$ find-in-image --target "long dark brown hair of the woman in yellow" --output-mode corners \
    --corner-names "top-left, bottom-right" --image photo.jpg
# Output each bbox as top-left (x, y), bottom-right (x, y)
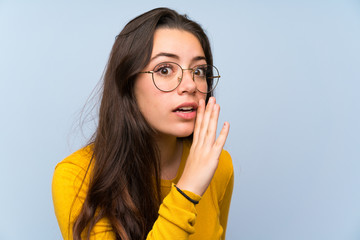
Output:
top-left (73, 8), bottom-right (213, 240)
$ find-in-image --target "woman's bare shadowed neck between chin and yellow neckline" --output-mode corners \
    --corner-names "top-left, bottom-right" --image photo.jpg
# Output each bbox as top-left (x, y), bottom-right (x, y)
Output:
top-left (156, 136), bottom-right (182, 179)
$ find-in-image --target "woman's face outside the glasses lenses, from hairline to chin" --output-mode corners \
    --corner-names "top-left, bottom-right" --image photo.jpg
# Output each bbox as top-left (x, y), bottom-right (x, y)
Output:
top-left (134, 28), bottom-right (206, 137)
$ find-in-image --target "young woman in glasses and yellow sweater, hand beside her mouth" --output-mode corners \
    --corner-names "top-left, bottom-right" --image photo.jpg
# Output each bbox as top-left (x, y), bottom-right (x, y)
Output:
top-left (52, 8), bottom-right (234, 240)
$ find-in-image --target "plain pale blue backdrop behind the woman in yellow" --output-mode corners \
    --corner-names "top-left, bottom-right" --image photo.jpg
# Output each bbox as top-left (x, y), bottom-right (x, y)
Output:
top-left (0, 0), bottom-right (360, 240)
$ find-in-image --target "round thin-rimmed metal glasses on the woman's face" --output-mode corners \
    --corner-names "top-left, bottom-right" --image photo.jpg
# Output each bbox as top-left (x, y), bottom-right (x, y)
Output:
top-left (140, 62), bottom-right (220, 94)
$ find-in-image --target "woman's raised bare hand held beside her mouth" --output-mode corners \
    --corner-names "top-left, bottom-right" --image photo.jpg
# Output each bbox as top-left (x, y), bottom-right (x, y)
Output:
top-left (177, 97), bottom-right (230, 196)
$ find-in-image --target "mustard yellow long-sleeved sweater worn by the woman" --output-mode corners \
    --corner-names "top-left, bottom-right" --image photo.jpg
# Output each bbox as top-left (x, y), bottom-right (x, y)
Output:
top-left (52, 142), bottom-right (234, 240)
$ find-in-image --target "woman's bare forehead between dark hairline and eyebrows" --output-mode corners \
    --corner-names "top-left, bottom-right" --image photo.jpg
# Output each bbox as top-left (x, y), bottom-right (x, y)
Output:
top-left (151, 28), bottom-right (205, 58)
